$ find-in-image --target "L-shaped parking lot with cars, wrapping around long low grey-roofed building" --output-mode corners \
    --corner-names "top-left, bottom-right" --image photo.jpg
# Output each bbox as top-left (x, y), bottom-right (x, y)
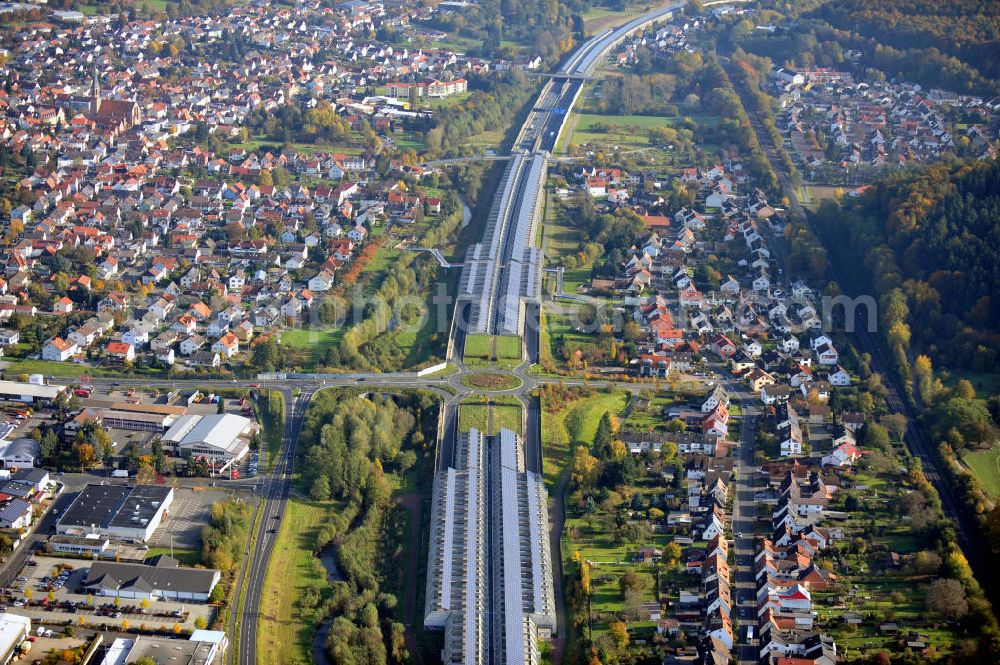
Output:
top-left (6, 556), bottom-right (214, 630)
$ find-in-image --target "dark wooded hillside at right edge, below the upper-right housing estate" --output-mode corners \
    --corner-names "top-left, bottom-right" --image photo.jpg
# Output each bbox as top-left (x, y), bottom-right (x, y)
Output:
top-left (814, 160), bottom-right (1000, 371)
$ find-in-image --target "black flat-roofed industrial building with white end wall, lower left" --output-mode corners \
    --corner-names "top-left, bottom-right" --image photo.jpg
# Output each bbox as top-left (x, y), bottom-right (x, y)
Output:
top-left (56, 485), bottom-right (174, 542)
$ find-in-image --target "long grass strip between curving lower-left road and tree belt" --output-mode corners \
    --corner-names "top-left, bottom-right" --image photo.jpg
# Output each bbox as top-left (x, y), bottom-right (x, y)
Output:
top-left (256, 498), bottom-right (333, 663)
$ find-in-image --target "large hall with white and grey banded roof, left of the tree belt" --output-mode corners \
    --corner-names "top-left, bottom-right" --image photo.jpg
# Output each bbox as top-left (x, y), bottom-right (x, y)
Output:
top-left (162, 413), bottom-right (258, 472)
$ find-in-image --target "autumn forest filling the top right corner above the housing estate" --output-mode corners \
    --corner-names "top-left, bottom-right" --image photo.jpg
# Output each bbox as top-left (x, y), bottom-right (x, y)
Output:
top-left (730, 0), bottom-right (1000, 96)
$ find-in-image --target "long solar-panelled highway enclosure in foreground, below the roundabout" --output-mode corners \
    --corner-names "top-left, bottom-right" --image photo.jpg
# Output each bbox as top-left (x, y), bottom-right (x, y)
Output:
top-left (424, 429), bottom-right (556, 665)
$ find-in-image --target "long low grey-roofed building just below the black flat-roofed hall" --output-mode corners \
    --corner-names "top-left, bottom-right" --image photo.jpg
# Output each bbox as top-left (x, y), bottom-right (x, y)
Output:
top-left (83, 554), bottom-right (222, 602)
